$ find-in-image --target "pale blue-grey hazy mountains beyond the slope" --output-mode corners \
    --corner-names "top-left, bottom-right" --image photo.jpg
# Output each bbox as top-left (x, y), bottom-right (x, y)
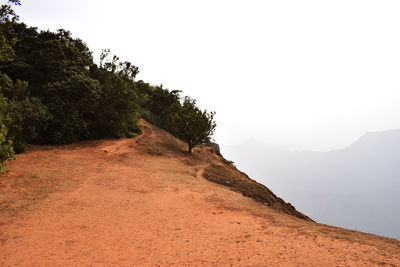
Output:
top-left (222, 130), bottom-right (400, 239)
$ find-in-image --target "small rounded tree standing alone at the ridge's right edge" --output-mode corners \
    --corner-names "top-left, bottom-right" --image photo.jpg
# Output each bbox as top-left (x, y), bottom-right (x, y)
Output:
top-left (175, 97), bottom-right (217, 153)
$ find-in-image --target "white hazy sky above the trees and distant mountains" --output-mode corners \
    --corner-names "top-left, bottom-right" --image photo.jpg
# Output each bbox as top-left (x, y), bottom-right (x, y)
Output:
top-left (12, 0), bottom-right (400, 151)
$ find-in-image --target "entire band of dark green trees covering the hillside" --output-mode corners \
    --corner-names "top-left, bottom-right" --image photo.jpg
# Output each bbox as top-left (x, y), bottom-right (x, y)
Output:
top-left (0, 0), bottom-right (215, 171)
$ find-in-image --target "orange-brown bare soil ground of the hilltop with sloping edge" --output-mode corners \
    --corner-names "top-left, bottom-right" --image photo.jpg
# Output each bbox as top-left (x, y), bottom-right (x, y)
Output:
top-left (0, 122), bottom-right (400, 266)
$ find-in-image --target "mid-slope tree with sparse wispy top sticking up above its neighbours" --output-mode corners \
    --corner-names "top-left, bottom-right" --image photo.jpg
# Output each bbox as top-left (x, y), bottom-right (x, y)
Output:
top-left (91, 50), bottom-right (140, 138)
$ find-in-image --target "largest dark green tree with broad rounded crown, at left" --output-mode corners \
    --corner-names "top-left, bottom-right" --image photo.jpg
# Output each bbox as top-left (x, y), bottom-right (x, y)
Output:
top-left (3, 23), bottom-right (101, 144)
